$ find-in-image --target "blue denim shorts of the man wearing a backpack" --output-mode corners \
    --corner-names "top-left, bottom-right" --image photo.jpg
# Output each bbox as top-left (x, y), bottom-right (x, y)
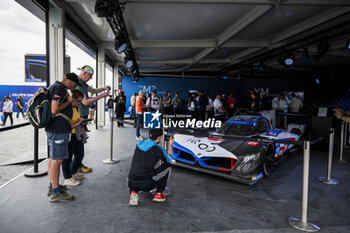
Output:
top-left (46, 132), bottom-right (70, 160)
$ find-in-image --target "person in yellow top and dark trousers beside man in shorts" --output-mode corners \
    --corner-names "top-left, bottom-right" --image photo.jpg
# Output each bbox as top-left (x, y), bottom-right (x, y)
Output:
top-left (62, 90), bottom-right (87, 186)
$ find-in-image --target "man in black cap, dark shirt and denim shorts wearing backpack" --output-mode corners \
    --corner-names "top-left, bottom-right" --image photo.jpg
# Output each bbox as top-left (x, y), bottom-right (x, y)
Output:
top-left (45, 73), bottom-right (80, 202)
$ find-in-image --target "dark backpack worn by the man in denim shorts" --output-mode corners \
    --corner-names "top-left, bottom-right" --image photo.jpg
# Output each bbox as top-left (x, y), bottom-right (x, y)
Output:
top-left (27, 87), bottom-right (70, 128)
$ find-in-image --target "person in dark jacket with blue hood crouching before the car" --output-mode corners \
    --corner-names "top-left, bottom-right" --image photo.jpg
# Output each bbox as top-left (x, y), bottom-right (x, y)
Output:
top-left (128, 129), bottom-right (174, 205)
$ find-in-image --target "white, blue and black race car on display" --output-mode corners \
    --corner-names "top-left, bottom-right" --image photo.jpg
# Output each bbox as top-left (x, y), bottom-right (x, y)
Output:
top-left (173, 115), bottom-right (305, 184)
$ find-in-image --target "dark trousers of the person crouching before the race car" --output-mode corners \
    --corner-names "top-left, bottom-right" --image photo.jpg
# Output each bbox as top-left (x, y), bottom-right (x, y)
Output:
top-left (128, 163), bottom-right (171, 193)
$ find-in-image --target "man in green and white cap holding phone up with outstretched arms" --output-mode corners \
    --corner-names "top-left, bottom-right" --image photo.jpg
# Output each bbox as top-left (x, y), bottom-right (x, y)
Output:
top-left (77, 65), bottom-right (111, 173)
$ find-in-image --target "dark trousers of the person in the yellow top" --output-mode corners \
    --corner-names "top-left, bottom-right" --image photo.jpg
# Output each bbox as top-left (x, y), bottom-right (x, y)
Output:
top-left (62, 134), bottom-right (84, 179)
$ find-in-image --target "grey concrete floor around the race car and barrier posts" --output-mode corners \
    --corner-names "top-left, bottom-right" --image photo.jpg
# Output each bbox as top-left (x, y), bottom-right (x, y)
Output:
top-left (0, 123), bottom-right (350, 233)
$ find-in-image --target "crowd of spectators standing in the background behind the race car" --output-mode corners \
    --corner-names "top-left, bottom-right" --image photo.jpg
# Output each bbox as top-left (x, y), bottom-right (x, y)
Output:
top-left (126, 90), bottom-right (303, 123)
